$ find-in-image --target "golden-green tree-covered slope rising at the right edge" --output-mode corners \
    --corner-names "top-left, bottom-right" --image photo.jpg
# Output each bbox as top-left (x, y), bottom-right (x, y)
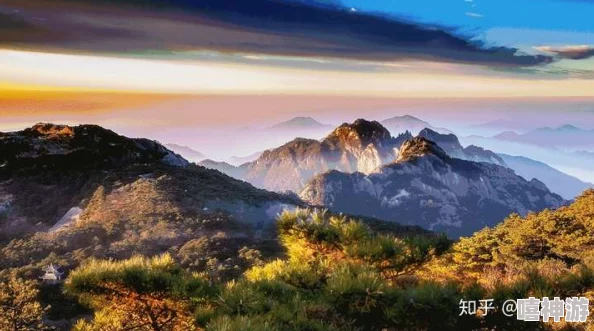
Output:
top-left (434, 189), bottom-right (594, 282)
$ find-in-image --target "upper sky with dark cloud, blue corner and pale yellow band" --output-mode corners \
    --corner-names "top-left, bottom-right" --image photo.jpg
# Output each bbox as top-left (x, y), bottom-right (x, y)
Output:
top-left (0, 0), bottom-right (594, 97)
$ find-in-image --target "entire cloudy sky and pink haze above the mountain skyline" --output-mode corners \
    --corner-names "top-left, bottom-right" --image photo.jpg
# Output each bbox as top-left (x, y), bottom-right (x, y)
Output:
top-left (0, 0), bottom-right (594, 165)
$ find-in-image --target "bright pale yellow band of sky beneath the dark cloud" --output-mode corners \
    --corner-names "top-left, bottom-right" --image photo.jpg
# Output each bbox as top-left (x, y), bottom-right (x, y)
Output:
top-left (0, 50), bottom-right (594, 98)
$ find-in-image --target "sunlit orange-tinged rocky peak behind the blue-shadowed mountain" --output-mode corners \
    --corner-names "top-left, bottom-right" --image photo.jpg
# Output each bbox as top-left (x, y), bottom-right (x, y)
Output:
top-left (242, 119), bottom-right (411, 192)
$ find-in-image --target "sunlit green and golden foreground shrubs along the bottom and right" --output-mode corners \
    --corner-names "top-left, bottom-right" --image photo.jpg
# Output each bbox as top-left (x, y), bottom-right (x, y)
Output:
top-left (52, 191), bottom-right (594, 331)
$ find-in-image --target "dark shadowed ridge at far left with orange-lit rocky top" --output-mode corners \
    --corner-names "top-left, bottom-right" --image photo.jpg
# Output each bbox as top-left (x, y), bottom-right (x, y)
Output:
top-left (0, 123), bottom-right (189, 178)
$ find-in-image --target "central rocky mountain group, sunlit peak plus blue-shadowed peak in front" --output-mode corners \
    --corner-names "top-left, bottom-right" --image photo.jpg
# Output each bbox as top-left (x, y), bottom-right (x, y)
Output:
top-left (192, 119), bottom-right (565, 237)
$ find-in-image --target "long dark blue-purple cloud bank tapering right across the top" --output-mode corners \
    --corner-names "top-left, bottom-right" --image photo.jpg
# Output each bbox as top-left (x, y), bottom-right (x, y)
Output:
top-left (0, 0), bottom-right (553, 67)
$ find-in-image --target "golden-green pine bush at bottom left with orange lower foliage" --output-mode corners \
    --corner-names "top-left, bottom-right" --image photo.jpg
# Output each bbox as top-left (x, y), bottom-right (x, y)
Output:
top-left (66, 255), bottom-right (208, 331)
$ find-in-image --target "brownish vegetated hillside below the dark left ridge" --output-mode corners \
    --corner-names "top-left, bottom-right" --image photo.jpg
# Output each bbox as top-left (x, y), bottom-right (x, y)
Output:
top-left (0, 165), bottom-right (302, 278)
